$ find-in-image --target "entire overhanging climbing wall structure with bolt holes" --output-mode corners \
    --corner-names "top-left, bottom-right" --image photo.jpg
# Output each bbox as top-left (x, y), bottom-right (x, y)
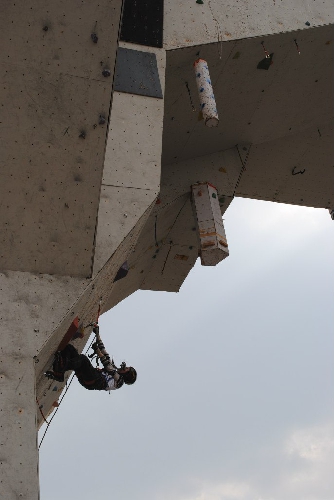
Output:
top-left (0, 0), bottom-right (334, 500)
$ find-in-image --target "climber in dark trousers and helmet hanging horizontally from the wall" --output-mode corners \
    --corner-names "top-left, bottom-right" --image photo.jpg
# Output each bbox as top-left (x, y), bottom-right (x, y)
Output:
top-left (45, 324), bottom-right (137, 391)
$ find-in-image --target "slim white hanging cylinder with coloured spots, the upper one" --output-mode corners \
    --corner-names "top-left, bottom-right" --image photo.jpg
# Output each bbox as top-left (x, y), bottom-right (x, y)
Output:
top-left (194, 59), bottom-right (219, 127)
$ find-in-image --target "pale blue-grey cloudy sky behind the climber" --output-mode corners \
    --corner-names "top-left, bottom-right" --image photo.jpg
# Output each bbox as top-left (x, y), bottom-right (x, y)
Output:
top-left (40, 199), bottom-right (334, 500)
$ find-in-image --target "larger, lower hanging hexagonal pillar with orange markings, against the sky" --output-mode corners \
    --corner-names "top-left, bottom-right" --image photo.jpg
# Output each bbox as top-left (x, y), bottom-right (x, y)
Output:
top-left (191, 182), bottom-right (229, 266)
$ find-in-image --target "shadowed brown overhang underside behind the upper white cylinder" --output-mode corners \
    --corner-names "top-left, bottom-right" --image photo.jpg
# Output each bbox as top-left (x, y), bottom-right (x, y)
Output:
top-left (162, 26), bottom-right (334, 164)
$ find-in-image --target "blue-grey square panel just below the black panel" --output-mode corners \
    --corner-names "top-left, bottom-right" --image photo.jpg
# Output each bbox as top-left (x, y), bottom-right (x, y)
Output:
top-left (114, 48), bottom-right (162, 99)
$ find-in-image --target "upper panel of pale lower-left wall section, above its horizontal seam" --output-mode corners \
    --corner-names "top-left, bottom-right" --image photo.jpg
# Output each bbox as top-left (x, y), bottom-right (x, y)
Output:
top-left (0, 271), bottom-right (87, 358)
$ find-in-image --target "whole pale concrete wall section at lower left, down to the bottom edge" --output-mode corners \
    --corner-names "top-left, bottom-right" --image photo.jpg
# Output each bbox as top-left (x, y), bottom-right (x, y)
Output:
top-left (0, 271), bottom-right (86, 500)
